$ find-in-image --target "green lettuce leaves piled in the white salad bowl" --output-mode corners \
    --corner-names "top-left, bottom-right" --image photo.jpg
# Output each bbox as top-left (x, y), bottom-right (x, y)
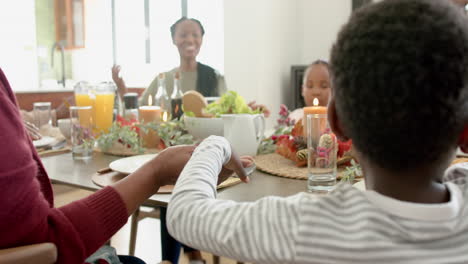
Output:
top-left (205, 91), bottom-right (262, 117)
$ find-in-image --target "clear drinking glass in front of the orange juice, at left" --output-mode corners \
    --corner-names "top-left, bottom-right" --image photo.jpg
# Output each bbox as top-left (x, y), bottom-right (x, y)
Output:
top-left (70, 106), bottom-right (94, 159)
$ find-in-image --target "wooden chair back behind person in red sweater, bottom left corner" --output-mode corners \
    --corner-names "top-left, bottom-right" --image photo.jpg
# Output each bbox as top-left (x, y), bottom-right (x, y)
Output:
top-left (0, 243), bottom-right (57, 264)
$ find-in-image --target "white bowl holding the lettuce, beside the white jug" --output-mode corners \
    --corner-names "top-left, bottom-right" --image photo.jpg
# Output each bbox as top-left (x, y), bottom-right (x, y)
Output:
top-left (184, 116), bottom-right (224, 139)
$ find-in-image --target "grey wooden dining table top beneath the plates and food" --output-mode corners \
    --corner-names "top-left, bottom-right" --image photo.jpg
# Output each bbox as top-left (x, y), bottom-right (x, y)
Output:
top-left (41, 152), bottom-right (307, 207)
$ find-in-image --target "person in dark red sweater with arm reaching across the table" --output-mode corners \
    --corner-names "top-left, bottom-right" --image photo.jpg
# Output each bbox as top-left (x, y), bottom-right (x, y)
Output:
top-left (0, 66), bottom-right (197, 264)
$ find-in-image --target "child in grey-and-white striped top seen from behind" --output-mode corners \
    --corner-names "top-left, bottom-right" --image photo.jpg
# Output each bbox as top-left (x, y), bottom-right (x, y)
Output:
top-left (168, 0), bottom-right (468, 264)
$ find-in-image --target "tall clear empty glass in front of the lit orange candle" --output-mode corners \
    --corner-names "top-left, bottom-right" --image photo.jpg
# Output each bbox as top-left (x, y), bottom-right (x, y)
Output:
top-left (306, 114), bottom-right (337, 192)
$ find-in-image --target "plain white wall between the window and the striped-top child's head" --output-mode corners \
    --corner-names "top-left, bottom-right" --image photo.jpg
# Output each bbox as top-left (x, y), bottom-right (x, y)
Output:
top-left (224, 0), bottom-right (351, 128)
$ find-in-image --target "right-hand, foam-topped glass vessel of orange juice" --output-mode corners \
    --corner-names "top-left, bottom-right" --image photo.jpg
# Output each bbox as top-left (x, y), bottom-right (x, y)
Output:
top-left (94, 82), bottom-right (116, 133)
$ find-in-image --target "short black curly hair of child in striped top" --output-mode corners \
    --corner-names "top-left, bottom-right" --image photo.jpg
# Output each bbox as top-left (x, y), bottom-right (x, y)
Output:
top-left (330, 0), bottom-right (468, 171)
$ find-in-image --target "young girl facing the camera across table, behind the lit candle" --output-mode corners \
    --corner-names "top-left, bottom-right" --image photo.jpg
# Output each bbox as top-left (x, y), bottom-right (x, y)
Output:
top-left (289, 60), bottom-right (331, 122)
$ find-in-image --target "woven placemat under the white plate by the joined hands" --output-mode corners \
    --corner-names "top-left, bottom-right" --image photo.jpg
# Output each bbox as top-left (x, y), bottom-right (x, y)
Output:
top-left (92, 171), bottom-right (241, 194)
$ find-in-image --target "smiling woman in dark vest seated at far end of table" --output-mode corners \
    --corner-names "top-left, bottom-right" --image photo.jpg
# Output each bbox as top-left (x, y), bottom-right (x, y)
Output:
top-left (112, 17), bottom-right (226, 263)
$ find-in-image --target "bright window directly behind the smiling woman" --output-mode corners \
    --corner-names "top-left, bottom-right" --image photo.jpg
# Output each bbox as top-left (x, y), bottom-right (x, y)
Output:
top-left (115, 0), bottom-right (224, 87)
